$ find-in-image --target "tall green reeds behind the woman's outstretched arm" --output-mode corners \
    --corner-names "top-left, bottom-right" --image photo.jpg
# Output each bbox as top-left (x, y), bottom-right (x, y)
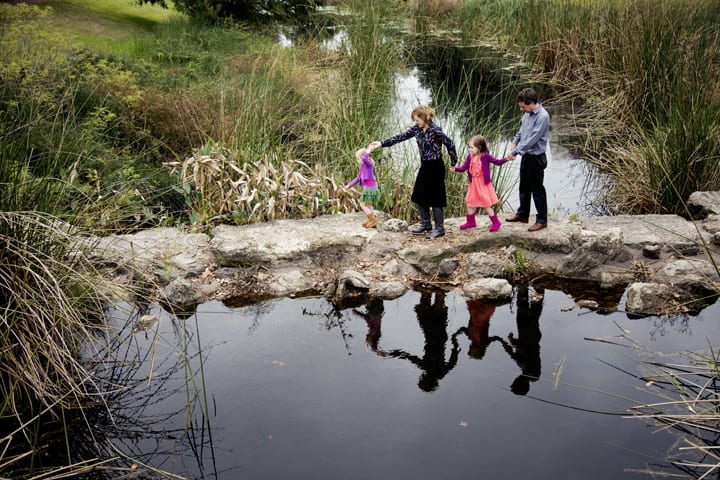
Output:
top-left (317, 0), bottom-right (414, 215)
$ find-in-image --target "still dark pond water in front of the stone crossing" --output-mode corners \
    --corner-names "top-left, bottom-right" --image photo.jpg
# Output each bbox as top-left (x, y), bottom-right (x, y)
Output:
top-left (95, 289), bottom-right (720, 480)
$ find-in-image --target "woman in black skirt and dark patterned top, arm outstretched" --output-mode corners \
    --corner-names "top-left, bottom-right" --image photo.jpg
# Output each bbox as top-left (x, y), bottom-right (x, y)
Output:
top-left (368, 105), bottom-right (457, 238)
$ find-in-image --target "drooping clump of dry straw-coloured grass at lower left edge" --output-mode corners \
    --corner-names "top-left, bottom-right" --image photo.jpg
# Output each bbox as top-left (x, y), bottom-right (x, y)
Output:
top-left (0, 211), bottom-right (119, 471)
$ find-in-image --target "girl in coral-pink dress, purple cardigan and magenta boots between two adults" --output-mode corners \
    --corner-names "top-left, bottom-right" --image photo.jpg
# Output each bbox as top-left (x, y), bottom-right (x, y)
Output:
top-left (450, 135), bottom-right (508, 232)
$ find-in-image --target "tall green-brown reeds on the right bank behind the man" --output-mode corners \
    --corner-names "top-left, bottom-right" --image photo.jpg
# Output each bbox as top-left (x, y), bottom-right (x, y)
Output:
top-left (458, 0), bottom-right (720, 213)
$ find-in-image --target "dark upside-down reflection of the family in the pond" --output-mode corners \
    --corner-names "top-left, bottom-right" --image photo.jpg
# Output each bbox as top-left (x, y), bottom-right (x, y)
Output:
top-left (362, 285), bottom-right (543, 395)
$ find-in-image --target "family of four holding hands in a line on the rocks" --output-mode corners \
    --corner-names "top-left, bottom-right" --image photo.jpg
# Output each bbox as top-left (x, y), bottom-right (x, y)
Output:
top-left (345, 88), bottom-right (550, 239)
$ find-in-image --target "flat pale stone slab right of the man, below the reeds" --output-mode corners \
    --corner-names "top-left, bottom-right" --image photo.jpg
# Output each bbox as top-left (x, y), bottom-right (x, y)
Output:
top-left (582, 215), bottom-right (710, 250)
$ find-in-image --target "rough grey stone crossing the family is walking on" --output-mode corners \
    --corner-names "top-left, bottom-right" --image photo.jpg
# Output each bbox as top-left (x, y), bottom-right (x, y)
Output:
top-left (95, 192), bottom-right (720, 315)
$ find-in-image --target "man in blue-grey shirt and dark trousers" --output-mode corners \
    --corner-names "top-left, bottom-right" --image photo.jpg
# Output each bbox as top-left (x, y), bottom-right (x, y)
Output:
top-left (505, 88), bottom-right (550, 232)
